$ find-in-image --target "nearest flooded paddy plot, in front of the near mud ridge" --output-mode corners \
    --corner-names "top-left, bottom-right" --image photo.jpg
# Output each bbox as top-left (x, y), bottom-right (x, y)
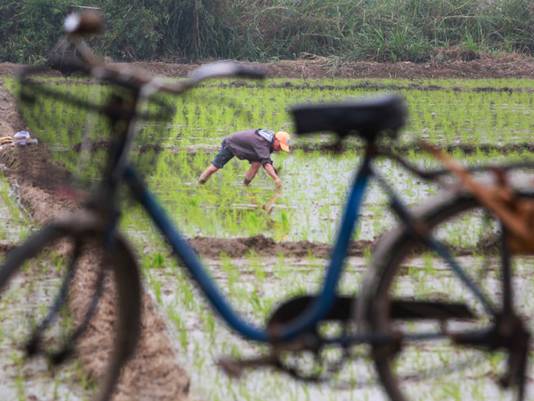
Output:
top-left (146, 253), bottom-right (534, 401)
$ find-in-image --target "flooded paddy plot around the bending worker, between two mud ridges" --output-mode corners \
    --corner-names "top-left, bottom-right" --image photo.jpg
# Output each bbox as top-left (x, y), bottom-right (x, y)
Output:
top-left (124, 151), bottom-right (529, 243)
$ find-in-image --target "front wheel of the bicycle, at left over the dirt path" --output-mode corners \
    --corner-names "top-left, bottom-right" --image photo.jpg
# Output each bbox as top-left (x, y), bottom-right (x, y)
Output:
top-left (0, 219), bottom-right (141, 401)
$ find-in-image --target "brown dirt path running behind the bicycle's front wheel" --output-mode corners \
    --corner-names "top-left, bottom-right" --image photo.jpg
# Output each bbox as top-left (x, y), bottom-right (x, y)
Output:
top-left (0, 79), bottom-right (189, 401)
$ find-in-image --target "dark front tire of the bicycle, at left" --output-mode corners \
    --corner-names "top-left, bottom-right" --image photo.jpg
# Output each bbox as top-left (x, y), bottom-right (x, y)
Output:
top-left (0, 218), bottom-right (142, 401)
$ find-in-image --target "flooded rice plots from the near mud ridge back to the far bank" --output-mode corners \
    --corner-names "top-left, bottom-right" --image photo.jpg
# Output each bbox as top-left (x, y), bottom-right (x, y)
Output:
top-left (13, 79), bottom-right (534, 242)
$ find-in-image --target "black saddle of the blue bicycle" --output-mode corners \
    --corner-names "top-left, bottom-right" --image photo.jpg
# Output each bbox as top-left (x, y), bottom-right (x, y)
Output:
top-left (289, 95), bottom-right (407, 140)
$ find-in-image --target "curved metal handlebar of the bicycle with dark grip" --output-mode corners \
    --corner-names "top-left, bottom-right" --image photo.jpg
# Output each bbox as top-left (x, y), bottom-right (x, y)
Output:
top-left (60, 10), bottom-right (265, 95)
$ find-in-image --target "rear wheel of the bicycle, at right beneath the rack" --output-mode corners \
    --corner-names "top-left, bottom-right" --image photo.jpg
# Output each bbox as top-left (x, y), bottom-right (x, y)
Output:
top-left (364, 186), bottom-right (534, 401)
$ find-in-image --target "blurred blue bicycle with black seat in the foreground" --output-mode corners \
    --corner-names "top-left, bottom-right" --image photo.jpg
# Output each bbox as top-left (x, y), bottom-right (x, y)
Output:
top-left (6, 9), bottom-right (534, 401)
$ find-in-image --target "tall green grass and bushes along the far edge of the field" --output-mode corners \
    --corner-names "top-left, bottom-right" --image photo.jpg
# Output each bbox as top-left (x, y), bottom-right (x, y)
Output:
top-left (0, 0), bottom-right (534, 63)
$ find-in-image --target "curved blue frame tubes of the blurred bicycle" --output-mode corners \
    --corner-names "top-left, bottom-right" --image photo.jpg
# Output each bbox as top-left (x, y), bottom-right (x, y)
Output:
top-left (124, 147), bottom-right (495, 343)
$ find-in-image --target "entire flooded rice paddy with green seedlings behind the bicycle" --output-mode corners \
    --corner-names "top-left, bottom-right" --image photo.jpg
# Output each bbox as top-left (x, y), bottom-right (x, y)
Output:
top-left (6, 78), bottom-right (534, 401)
